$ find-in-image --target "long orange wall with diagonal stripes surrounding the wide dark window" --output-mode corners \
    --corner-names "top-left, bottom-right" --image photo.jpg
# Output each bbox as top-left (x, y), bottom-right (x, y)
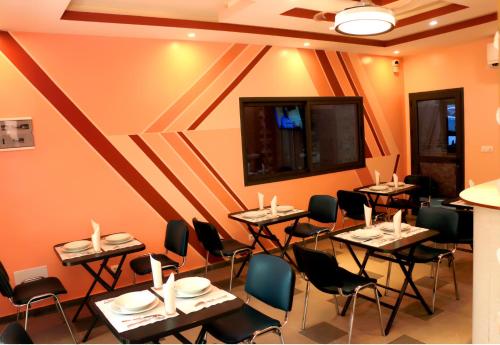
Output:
top-left (0, 33), bottom-right (406, 316)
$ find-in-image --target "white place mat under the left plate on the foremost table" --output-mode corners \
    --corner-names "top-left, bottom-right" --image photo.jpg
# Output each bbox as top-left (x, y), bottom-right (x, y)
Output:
top-left (96, 290), bottom-right (179, 333)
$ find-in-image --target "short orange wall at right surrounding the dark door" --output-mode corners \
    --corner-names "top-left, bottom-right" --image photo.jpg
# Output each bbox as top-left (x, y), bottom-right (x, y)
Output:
top-left (404, 38), bottom-right (500, 186)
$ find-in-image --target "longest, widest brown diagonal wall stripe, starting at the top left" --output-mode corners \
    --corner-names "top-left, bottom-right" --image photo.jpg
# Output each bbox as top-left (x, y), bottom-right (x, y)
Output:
top-left (0, 31), bottom-right (209, 256)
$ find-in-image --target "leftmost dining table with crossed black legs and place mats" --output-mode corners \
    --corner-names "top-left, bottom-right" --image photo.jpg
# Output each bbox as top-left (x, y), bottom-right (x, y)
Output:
top-left (54, 233), bottom-right (146, 342)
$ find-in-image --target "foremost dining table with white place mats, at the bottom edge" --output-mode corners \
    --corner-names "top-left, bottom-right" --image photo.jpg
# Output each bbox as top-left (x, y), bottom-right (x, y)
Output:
top-left (90, 282), bottom-right (244, 344)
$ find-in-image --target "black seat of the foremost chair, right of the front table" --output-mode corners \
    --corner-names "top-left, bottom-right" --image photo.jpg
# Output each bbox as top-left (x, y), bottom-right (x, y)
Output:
top-left (206, 304), bottom-right (281, 344)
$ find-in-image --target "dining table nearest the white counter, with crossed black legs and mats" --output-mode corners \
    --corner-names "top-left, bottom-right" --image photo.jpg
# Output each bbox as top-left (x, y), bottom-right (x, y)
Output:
top-left (329, 223), bottom-right (439, 335)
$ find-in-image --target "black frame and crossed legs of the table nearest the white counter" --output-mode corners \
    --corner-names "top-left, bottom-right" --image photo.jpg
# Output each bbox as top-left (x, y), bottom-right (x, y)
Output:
top-left (330, 228), bottom-right (439, 335)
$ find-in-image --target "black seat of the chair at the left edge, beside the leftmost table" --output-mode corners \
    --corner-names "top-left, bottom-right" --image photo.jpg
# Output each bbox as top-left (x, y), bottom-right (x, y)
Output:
top-left (12, 277), bottom-right (67, 305)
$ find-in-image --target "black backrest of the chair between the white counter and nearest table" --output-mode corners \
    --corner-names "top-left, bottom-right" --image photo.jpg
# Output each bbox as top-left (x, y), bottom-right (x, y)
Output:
top-left (416, 207), bottom-right (458, 243)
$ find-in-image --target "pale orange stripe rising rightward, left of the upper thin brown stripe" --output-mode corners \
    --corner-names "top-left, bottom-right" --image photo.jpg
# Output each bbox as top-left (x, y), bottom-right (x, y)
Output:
top-left (146, 44), bottom-right (247, 132)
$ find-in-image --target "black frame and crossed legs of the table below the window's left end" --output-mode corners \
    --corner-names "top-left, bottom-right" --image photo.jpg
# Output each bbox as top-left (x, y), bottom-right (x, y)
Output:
top-left (228, 209), bottom-right (309, 277)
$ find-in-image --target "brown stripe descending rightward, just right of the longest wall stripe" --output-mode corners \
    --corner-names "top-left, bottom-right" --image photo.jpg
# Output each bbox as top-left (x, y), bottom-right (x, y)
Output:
top-left (130, 134), bottom-right (231, 238)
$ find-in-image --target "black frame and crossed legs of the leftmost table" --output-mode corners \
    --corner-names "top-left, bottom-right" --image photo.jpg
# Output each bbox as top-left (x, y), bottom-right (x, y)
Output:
top-left (54, 239), bottom-right (146, 342)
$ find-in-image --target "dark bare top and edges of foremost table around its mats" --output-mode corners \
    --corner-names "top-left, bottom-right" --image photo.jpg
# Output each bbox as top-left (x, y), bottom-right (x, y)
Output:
top-left (90, 282), bottom-right (244, 343)
